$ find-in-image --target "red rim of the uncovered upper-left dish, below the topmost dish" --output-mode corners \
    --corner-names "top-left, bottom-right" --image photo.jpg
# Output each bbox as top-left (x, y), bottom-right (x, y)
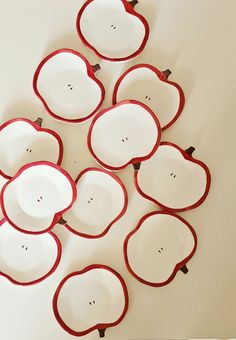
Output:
top-left (33, 48), bottom-right (105, 123)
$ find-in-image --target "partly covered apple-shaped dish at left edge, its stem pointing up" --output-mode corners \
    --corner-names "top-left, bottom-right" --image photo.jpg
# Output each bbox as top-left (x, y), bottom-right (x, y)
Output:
top-left (0, 118), bottom-right (63, 178)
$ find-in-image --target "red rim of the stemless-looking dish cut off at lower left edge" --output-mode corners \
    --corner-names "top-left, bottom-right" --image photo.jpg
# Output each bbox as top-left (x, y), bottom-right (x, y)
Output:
top-left (0, 219), bottom-right (62, 286)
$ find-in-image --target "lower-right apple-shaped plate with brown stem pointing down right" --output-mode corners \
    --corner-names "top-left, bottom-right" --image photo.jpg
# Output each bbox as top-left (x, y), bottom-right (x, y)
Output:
top-left (124, 211), bottom-right (197, 287)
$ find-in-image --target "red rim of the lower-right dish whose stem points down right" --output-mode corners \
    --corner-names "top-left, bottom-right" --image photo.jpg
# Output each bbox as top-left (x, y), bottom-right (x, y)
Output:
top-left (123, 211), bottom-right (197, 287)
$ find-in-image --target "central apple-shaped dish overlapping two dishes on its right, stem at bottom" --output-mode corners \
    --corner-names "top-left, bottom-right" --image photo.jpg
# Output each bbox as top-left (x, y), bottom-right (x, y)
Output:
top-left (88, 100), bottom-right (161, 171)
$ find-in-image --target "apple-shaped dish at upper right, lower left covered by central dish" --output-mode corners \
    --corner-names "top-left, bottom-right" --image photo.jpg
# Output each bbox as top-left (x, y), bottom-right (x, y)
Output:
top-left (113, 64), bottom-right (185, 130)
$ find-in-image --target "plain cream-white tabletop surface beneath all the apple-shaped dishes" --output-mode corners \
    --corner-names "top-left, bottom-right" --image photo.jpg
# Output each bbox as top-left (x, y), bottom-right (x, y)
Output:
top-left (0, 0), bottom-right (236, 340)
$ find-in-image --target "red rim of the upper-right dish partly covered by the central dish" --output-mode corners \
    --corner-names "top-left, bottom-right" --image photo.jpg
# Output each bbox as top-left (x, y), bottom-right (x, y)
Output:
top-left (112, 64), bottom-right (185, 131)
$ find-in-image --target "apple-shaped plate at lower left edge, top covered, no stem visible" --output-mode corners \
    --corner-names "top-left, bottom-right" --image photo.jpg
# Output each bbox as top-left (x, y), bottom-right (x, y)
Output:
top-left (0, 220), bottom-right (61, 286)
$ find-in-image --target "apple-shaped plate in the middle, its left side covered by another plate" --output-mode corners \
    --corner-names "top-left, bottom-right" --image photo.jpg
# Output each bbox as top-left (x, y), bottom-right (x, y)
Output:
top-left (63, 168), bottom-right (128, 238)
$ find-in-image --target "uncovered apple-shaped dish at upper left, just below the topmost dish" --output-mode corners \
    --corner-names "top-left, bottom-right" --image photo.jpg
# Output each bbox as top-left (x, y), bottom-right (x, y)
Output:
top-left (33, 49), bottom-right (105, 123)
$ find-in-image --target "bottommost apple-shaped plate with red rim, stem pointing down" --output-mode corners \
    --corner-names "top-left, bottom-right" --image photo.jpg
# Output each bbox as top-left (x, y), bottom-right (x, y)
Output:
top-left (53, 265), bottom-right (129, 338)
